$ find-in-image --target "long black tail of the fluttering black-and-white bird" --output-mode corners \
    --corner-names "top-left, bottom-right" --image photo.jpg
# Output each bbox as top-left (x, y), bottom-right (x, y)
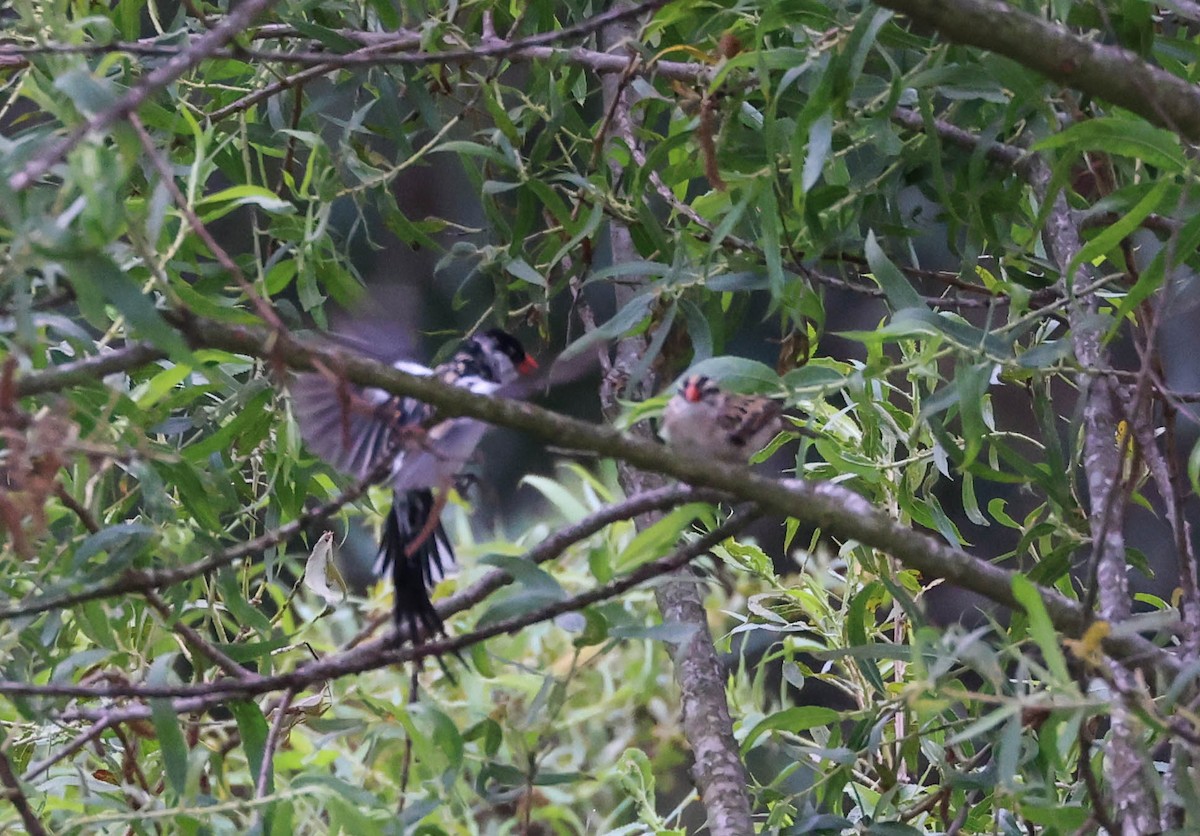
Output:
top-left (376, 489), bottom-right (454, 643)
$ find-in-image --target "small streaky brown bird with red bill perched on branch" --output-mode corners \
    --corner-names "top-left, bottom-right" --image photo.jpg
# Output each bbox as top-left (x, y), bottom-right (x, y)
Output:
top-left (660, 374), bottom-right (785, 464)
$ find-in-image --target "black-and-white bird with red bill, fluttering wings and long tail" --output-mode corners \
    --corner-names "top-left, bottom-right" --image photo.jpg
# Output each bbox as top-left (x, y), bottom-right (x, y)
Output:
top-left (292, 329), bottom-right (538, 640)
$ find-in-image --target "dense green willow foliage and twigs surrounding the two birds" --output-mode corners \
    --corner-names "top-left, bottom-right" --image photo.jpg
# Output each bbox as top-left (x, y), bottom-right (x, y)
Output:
top-left (0, 0), bottom-right (1200, 836)
